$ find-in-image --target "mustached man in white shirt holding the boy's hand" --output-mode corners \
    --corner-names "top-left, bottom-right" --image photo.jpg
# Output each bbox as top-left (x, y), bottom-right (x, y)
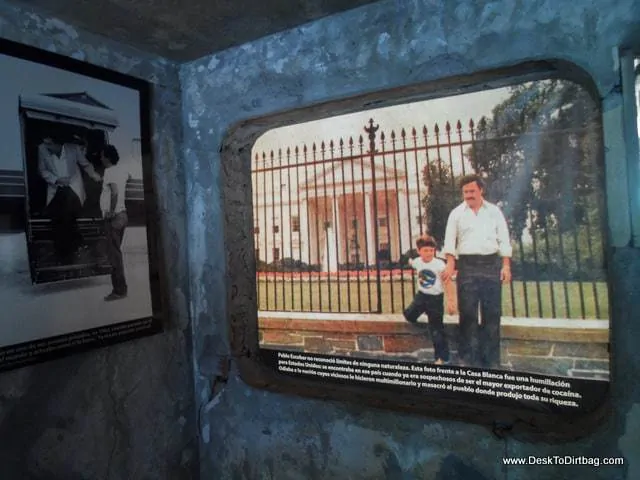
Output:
top-left (443, 175), bottom-right (513, 368)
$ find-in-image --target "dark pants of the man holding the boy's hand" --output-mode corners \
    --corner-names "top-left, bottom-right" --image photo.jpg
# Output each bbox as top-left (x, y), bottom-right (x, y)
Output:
top-left (456, 255), bottom-right (502, 368)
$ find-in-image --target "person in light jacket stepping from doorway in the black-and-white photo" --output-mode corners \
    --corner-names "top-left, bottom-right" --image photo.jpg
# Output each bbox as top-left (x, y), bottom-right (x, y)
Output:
top-left (38, 135), bottom-right (101, 263)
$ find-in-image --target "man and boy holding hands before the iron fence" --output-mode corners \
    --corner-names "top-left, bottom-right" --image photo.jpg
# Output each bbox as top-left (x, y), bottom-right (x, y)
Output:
top-left (403, 175), bottom-right (512, 368)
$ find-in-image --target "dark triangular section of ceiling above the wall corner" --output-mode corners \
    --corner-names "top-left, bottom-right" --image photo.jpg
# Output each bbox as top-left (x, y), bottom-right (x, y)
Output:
top-left (19, 0), bottom-right (376, 62)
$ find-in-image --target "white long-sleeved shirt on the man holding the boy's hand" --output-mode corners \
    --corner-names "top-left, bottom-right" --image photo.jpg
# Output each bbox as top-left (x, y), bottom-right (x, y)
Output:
top-left (443, 200), bottom-right (513, 257)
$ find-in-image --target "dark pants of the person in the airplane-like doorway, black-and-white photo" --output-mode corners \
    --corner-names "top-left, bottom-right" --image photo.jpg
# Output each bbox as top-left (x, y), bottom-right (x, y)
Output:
top-left (47, 186), bottom-right (83, 262)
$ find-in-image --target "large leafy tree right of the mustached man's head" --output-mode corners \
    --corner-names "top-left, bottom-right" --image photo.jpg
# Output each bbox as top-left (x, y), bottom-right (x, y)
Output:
top-left (468, 80), bottom-right (602, 242)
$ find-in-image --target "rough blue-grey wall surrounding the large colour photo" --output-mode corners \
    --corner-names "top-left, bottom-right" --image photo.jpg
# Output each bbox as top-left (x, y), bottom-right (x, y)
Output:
top-left (181, 0), bottom-right (640, 479)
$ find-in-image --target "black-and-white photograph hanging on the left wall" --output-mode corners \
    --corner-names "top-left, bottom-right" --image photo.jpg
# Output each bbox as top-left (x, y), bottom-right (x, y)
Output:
top-left (0, 45), bottom-right (159, 367)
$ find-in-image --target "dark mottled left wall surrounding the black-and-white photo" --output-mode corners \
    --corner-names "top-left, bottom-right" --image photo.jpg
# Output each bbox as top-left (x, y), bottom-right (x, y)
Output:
top-left (0, 1), bottom-right (198, 480)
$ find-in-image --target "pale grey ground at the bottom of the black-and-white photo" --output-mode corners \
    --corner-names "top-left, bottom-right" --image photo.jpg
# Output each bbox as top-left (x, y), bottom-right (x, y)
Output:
top-left (0, 227), bottom-right (151, 347)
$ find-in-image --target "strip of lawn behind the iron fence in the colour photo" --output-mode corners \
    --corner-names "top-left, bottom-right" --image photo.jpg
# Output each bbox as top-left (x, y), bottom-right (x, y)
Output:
top-left (258, 276), bottom-right (609, 319)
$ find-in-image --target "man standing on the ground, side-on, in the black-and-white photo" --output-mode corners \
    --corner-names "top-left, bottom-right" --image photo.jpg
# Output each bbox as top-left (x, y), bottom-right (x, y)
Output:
top-left (100, 145), bottom-right (129, 301)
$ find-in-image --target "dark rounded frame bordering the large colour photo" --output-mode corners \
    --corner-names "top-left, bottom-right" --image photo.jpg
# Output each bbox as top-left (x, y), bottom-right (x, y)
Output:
top-left (221, 59), bottom-right (615, 442)
